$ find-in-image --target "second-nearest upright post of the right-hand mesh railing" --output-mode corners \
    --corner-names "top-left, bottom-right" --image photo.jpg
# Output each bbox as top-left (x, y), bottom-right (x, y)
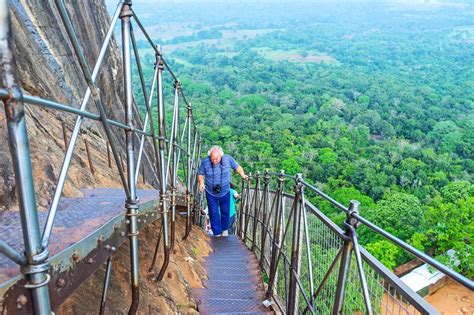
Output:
top-left (286, 174), bottom-right (303, 314)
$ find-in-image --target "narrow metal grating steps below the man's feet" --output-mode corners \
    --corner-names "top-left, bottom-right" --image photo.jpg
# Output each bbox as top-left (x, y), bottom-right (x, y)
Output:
top-left (193, 235), bottom-right (273, 314)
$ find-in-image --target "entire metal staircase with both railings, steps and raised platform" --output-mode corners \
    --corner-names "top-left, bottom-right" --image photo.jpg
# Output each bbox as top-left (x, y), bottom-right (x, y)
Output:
top-left (0, 0), bottom-right (474, 314)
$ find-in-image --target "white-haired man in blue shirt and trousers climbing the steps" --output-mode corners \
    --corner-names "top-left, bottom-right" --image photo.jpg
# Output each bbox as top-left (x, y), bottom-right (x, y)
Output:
top-left (198, 146), bottom-right (248, 236)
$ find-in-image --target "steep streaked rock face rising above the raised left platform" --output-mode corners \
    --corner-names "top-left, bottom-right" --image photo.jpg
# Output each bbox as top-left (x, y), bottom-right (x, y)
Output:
top-left (0, 0), bottom-right (155, 210)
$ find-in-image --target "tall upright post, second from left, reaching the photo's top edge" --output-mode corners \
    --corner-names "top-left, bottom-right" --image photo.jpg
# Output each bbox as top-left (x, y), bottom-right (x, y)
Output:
top-left (120, 1), bottom-right (140, 314)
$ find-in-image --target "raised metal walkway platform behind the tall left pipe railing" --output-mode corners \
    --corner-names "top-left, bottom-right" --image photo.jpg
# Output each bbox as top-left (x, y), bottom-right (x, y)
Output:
top-left (0, 188), bottom-right (185, 314)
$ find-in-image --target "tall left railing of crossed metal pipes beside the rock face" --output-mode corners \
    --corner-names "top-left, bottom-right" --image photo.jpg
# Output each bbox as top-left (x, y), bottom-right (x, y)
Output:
top-left (0, 0), bottom-right (203, 314)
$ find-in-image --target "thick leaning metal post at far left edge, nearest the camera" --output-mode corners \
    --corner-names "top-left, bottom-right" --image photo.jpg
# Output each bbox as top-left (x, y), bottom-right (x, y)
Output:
top-left (0, 0), bottom-right (51, 314)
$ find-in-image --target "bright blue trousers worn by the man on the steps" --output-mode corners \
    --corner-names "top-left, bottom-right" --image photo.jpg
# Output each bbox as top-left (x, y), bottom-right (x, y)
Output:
top-left (206, 192), bottom-right (230, 235)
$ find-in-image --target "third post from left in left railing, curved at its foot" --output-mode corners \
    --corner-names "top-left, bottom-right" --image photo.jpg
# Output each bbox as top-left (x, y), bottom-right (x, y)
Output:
top-left (156, 50), bottom-right (170, 281)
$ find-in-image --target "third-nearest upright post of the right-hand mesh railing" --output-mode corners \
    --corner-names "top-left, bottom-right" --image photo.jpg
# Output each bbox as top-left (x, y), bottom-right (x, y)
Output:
top-left (265, 170), bottom-right (285, 299)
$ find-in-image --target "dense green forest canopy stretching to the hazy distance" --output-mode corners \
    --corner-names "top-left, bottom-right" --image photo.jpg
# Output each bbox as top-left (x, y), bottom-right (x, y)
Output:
top-left (105, 1), bottom-right (474, 277)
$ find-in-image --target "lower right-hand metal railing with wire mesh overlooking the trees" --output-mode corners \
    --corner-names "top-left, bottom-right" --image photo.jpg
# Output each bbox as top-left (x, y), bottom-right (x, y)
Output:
top-left (236, 171), bottom-right (473, 314)
